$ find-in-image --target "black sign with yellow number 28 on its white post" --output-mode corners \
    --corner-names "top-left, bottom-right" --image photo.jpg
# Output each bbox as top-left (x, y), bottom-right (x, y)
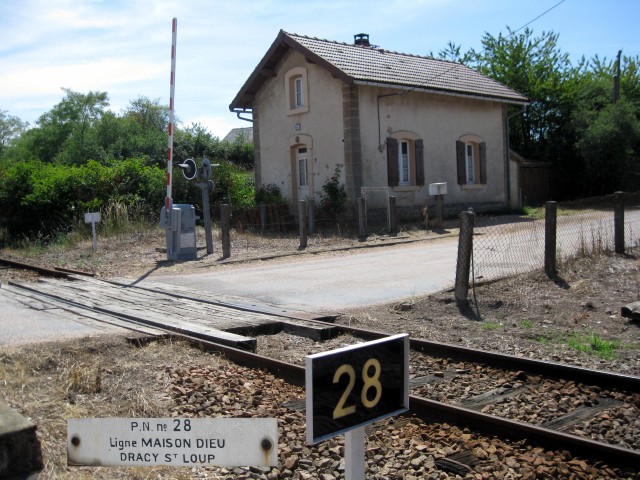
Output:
top-left (305, 334), bottom-right (409, 480)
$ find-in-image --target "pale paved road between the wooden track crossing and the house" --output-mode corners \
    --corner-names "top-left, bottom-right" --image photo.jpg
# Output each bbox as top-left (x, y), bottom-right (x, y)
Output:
top-left (142, 210), bottom-right (640, 312)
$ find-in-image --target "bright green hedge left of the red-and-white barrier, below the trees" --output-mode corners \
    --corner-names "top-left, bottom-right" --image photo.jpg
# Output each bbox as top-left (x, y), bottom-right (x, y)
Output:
top-left (0, 159), bottom-right (166, 240)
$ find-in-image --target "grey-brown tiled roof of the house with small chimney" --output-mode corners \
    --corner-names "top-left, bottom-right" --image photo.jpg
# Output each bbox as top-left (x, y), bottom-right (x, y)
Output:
top-left (230, 31), bottom-right (528, 110)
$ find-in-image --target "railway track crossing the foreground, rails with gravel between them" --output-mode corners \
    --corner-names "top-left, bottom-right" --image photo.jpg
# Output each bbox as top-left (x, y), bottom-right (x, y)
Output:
top-left (3, 255), bottom-right (640, 468)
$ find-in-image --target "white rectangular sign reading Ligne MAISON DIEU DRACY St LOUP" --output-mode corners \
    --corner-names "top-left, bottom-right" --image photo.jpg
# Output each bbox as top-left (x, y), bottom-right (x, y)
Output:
top-left (67, 418), bottom-right (278, 467)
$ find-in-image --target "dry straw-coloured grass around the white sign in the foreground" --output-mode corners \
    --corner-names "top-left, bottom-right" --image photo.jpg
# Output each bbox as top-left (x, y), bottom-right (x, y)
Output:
top-left (0, 337), bottom-right (232, 480)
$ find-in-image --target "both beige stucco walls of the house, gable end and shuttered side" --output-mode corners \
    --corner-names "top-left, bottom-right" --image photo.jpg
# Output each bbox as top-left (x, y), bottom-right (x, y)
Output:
top-left (256, 51), bottom-right (507, 213)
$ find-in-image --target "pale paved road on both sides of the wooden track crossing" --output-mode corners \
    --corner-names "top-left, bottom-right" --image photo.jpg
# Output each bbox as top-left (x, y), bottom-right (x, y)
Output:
top-left (5, 210), bottom-right (640, 346)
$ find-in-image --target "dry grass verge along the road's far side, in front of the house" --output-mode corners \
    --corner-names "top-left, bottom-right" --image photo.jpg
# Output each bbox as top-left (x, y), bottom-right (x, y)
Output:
top-left (0, 221), bottom-right (456, 281)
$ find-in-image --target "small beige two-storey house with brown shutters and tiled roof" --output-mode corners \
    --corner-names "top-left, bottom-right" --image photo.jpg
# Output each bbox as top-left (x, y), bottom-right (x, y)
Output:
top-left (229, 31), bottom-right (528, 213)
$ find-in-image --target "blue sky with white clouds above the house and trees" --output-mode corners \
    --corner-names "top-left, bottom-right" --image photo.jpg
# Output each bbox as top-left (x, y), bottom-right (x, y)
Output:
top-left (0, 0), bottom-right (640, 137)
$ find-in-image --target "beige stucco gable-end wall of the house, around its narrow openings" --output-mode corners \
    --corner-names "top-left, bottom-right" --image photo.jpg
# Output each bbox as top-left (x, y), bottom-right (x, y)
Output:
top-left (256, 52), bottom-right (344, 202)
